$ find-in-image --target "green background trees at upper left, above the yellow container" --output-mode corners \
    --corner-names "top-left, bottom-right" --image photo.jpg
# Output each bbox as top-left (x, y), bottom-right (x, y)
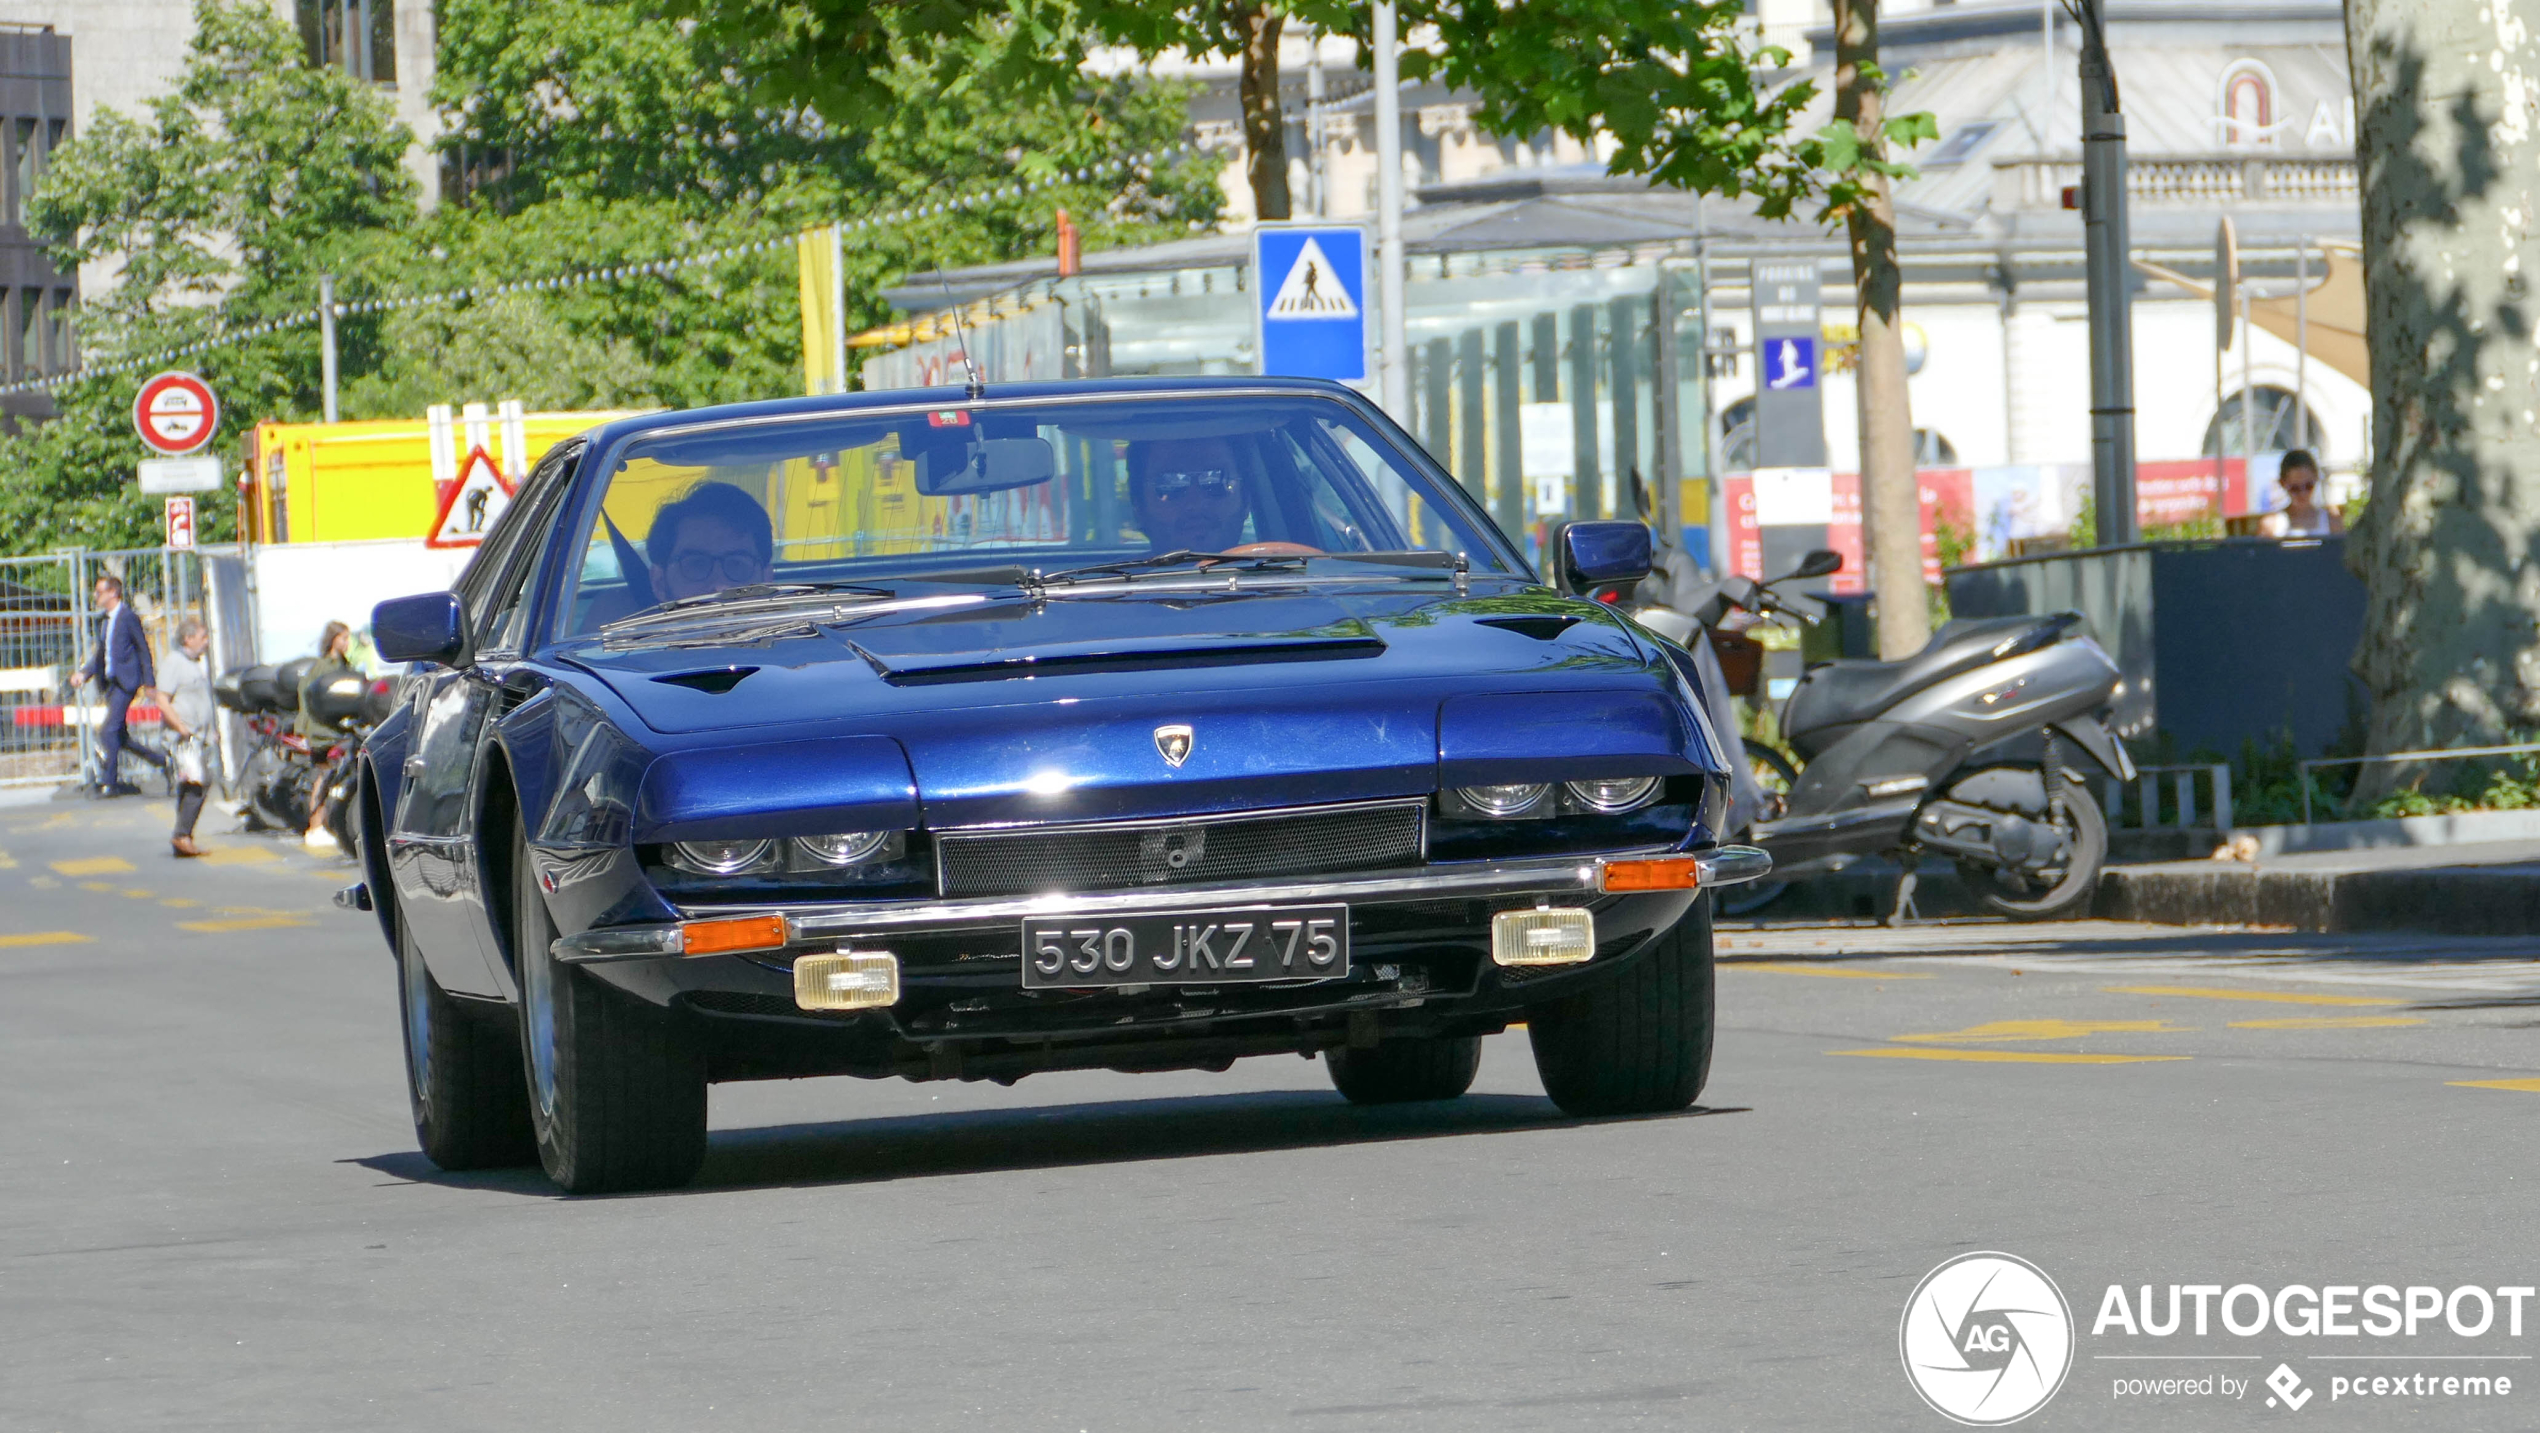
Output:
top-left (0, 0), bottom-right (1219, 551)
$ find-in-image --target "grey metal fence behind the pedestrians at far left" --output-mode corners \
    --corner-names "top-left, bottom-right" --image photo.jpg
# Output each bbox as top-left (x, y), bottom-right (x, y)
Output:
top-left (0, 546), bottom-right (257, 785)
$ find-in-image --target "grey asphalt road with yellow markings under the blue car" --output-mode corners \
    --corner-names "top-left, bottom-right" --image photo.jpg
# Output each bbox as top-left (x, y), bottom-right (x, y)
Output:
top-left (0, 800), bottom-right (2540, 1433)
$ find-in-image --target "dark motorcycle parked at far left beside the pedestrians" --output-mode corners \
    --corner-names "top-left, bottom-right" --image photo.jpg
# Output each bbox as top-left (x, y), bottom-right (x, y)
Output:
top-left (211, 658), bottom-right (394, 851)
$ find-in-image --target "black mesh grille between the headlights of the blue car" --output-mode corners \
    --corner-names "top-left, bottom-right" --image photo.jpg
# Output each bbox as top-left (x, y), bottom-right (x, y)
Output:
top-left (935, 800), bottom-right (1425, 897)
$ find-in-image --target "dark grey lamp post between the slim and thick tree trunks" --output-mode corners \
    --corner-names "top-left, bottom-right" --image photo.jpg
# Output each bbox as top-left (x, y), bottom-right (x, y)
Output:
top-left (2078, 0), bottom-right (2139, 546)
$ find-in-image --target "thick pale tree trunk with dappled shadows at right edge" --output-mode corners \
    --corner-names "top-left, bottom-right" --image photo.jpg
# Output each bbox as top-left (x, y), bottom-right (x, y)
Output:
top-left (2347, 0), bottom-right (2540, 800)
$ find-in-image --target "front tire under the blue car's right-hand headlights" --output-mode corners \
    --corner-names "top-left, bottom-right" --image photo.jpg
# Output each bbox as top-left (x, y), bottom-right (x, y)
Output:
top-left (1527, 899), bottom-right (1712, 1115)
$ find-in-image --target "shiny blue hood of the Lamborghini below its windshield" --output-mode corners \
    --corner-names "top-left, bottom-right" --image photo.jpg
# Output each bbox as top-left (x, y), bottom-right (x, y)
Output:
top-left (561, 589), bottom-right (1674, 826)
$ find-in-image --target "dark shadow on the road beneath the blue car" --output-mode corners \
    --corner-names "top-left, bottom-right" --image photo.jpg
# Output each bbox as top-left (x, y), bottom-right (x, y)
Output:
top-left (351, 1090), bottom-right (1748, 1197)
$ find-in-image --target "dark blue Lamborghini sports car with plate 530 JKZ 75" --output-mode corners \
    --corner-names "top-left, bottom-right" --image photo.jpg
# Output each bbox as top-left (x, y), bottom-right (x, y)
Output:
top-left (340, 379), bottom-right (1768, 1192)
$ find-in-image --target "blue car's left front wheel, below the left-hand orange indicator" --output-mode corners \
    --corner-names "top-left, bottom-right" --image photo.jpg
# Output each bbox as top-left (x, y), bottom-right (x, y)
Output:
top-left (511, 828), bottom-right (706, 1194)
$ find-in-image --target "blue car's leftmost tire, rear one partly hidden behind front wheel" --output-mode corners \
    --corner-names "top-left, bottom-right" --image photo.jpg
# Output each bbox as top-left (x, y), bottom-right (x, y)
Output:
top-left (396, 914), bottom-right (538, 1171)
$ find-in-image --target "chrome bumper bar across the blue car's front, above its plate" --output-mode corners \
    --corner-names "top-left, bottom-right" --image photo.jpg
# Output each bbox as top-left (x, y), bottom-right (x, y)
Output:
top-left (551, 846), bottom-right (1773, 965)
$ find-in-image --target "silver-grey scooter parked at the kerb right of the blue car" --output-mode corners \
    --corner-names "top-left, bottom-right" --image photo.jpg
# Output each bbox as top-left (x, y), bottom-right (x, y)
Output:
top-left (1636, 551), bottom-right (2134, 920)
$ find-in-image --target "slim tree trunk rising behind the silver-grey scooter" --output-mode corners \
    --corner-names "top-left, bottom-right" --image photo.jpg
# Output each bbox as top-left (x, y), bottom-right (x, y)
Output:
top-left (1834, 0), bottom-right (1930, 661)
